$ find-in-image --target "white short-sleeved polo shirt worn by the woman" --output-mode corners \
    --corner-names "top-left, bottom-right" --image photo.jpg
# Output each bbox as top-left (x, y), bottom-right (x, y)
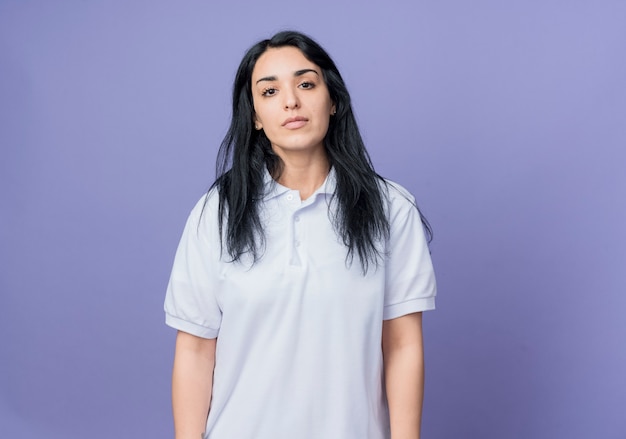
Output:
top-left (165, 171), bottom-right (436, 439)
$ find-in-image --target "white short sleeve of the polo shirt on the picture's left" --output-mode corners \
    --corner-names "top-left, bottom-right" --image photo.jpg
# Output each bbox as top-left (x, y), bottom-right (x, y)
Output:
top-left (164, 197), bottom-right (222, 338)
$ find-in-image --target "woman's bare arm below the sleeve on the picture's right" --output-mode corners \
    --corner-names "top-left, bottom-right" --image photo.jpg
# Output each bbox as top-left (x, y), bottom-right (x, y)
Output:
top-left (383, 313), bottom-right (424, 439)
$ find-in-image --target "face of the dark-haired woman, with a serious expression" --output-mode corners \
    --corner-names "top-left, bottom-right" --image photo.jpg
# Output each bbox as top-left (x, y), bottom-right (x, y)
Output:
top-left (252, 46), bottom-right (335, 157)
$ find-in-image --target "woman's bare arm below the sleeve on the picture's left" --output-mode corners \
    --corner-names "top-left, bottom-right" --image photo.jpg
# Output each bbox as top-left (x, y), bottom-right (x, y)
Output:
top-left (172, 331), bottom-right (217, 439)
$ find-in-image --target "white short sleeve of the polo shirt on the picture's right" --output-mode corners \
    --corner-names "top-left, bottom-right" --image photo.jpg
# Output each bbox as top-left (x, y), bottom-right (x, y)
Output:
top-left (383, 185), bottom-right (437, 320)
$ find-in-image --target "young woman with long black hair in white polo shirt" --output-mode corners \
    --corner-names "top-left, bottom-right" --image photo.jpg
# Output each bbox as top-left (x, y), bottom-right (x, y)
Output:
top-left (165, 32), bottom-right (436, 439)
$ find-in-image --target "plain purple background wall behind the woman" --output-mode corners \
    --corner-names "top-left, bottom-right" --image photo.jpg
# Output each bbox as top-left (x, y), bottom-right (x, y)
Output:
top-left (0, 0), bottom-right (626, 439)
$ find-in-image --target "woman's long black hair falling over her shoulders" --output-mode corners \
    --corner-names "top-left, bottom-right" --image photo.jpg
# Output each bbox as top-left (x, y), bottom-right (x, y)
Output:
top-left (211, 31), bottom-right (430, 273)
